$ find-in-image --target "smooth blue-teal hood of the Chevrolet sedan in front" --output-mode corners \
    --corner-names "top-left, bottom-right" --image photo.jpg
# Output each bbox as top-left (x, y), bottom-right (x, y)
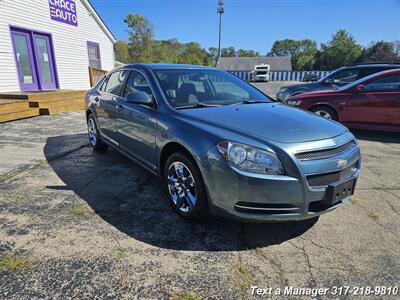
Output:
top-left (179, 103), bottom-right (347, 143)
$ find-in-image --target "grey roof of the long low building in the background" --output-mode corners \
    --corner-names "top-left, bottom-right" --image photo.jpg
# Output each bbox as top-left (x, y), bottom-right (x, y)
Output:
top-left (217, 56), bottom-right (292, 71)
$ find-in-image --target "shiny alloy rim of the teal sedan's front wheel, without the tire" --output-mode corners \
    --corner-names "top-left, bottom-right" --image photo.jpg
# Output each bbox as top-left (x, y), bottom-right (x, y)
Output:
top-left (168, 161), bottom-right (197, 214)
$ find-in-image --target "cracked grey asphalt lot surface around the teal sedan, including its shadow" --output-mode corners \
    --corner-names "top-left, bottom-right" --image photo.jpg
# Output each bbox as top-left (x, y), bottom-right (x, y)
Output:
top-left (0, 105), bottom-right (400, 299)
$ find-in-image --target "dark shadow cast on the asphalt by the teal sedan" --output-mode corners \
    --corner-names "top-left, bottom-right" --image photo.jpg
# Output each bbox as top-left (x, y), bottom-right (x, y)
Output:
top-left (44, 134), bottom-right (316, 251)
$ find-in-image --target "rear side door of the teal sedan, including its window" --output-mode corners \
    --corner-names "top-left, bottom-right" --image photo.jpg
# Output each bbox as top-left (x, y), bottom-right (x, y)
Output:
top-left (94, 70), bottom-right (128, 145)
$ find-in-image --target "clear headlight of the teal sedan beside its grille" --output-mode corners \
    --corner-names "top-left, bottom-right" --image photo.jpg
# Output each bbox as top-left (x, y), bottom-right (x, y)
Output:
top-left (217, 141), bottom-right (283, 174)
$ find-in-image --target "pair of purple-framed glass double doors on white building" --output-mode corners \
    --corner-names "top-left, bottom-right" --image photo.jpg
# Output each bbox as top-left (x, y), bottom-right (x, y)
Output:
top-left (11, 28), bottom-right (57, 91)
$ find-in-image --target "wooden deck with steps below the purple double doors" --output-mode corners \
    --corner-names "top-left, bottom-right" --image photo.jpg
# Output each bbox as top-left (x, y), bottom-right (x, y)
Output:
top-left (0, 90), bottom-right (85, 123)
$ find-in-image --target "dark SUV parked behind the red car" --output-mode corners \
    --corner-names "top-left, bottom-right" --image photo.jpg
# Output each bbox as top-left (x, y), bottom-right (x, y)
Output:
top-left (276, 64), bottom-right (400, 103)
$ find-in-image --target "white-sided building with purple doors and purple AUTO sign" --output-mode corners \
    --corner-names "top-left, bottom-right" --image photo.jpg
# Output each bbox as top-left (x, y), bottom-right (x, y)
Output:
top-left (0, 0), bottom-right (116, 92)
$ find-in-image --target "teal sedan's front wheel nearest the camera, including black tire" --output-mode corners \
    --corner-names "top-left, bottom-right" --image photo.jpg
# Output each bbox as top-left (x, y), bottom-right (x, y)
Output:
top-left (163, 152), bottom-right (208, 221)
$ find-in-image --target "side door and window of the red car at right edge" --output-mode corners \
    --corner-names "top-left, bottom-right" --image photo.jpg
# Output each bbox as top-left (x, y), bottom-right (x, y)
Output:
top-left (346, 74), bottom-right (400, 127)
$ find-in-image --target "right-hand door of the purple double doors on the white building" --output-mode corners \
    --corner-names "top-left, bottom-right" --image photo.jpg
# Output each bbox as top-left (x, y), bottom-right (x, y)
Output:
top-left (33, 33), bottom-right (57, 90)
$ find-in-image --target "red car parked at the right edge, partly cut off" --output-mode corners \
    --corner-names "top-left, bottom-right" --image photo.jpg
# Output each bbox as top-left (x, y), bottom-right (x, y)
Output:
top-left (286, 69), bottom-right (400, 132)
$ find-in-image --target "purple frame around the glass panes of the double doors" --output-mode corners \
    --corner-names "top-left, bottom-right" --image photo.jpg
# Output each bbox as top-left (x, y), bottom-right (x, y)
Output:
top-left (9, 25), bottom-right (60, 91)
